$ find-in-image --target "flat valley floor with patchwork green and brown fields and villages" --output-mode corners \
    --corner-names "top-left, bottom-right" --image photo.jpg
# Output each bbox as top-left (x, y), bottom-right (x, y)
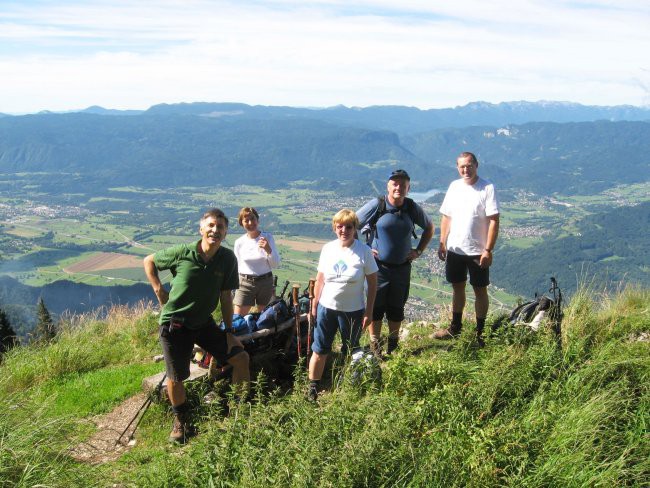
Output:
top-left (0, 176), bottom-right (650, 318)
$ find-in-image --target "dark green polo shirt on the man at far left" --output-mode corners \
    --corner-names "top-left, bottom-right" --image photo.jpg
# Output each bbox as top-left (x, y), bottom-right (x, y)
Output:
top-left (153, 241), bottom-right (239, 329)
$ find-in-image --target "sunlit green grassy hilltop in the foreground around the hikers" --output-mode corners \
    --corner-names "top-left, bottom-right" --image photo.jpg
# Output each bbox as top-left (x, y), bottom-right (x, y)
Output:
top-left (0, 289), bottom-right (650, 487)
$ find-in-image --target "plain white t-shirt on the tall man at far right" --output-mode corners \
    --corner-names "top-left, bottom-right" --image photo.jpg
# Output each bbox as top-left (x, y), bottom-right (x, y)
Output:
top-left (440, 177), bottom-right (499, 256)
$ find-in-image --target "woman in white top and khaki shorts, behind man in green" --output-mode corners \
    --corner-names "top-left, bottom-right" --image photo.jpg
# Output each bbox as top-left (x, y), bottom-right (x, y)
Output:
top-left (233, 207), bottom-right (280, 316)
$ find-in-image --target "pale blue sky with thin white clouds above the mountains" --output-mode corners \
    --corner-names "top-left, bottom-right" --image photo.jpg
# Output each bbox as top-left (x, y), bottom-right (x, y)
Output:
top-left (0, 0), bottom-right (650, 113)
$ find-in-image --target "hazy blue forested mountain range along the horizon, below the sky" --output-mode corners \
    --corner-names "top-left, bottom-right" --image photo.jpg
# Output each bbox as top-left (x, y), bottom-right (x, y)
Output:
top-left (0, 102), bottom-right (650, 194)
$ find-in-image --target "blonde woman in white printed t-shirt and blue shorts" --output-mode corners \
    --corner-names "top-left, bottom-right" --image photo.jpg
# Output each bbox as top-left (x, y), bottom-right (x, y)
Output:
top-left (308, 209), bottom-right (378, 400)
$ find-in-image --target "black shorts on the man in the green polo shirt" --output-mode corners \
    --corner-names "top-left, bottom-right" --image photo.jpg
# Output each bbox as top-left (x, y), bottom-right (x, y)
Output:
top-left (160, 319), bottom-right (243, 381)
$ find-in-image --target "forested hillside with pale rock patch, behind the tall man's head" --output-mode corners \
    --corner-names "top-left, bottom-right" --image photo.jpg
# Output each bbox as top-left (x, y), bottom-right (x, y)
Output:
top-left (402, 121), bottom-right (650, 195)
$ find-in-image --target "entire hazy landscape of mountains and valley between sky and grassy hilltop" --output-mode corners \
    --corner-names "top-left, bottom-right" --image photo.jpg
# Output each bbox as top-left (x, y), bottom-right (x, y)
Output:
top-left (0, 102), bottom-right (650, 334)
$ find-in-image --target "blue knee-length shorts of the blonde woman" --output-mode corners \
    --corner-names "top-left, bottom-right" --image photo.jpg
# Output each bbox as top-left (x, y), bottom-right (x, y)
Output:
top-left (312, 303), bottom-right (364, 354)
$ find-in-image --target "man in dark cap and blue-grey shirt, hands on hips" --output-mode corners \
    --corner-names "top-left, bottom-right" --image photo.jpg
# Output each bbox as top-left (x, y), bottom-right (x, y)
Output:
top-left (357, 169), bottom-right (434, 358)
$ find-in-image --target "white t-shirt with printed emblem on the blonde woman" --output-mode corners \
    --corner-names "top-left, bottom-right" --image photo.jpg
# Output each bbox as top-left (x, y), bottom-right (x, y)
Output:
top-left (318, 239), bottom-right (378, 312)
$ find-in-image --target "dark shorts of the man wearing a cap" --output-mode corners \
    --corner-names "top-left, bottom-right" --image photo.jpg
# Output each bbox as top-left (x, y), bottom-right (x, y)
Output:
top-left (372, 261), bottom-right (411, 322)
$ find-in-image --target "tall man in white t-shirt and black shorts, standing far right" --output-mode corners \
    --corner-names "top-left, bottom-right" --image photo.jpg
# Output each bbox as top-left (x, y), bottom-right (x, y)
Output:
top-left (434, 152), bottom-right (499, 345)
